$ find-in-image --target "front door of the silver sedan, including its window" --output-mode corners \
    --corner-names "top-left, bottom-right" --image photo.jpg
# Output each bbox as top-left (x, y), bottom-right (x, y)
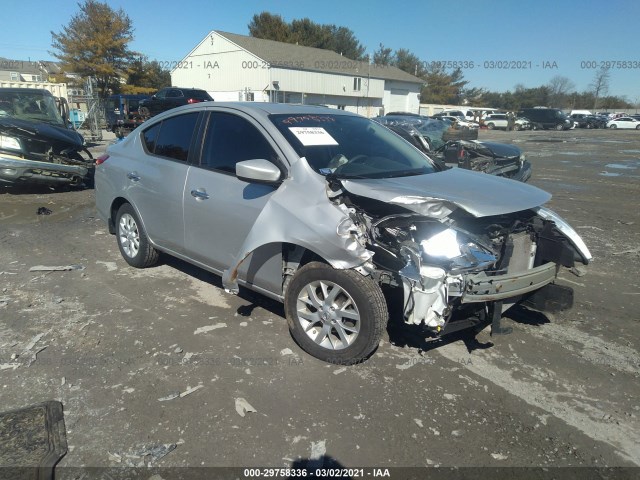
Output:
top-left (184, 111), bottom-right (282, 271)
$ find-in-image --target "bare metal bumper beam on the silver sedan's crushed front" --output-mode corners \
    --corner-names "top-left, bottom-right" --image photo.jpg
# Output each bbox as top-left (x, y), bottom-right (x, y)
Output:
top-left (461, 262), bottom-right (558, 303)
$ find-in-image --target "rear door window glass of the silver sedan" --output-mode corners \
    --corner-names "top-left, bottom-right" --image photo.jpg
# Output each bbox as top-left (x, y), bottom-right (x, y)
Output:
top-left (143, 112), bottom-right (198, 162)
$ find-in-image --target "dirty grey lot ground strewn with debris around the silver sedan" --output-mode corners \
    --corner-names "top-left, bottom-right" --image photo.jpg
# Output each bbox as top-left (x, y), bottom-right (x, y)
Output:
top-left (0, 126), bottom-right (640, 467)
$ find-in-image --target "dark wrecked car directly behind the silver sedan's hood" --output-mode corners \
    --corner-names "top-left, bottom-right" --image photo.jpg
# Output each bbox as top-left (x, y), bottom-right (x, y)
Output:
top-left (374, 115), bottom-right (531, 182)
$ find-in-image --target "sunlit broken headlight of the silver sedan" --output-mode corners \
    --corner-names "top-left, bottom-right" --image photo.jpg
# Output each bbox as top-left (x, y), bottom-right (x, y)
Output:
top-left (420, 228), bottom-right (497, 274)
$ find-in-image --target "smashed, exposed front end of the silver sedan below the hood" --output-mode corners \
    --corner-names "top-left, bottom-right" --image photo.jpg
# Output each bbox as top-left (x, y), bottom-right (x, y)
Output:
top-left (328, 174), bottom-right (591, 334)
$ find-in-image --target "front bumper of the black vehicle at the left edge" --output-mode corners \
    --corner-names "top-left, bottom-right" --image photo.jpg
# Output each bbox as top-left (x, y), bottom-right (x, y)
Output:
top-left (0, 154), bottom-right (89, 184)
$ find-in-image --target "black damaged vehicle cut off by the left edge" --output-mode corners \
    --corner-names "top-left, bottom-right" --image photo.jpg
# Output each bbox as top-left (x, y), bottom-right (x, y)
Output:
top-left (0, 88), bottom-right (93, 185)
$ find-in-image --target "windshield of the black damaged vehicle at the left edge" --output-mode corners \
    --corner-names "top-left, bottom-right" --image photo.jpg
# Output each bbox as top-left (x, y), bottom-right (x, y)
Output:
top-left (0, 90), bottom-right (64, 127)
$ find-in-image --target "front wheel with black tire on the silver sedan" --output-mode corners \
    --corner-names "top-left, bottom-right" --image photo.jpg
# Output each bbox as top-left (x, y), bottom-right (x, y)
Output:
top-left (284, 262), bottom-right (389, 365)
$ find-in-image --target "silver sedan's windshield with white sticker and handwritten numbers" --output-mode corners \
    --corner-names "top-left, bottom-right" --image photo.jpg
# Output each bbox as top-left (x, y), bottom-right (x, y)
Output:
top-left (270, 114), bottom-right (436, 178)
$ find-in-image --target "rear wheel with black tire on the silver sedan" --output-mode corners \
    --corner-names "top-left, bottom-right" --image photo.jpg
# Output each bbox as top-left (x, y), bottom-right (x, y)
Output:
top-left (116, 203), bottom-right (159, 268)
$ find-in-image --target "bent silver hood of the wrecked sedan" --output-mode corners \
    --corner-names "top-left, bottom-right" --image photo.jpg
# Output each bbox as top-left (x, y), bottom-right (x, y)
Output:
top-left (342, 168), bottom-right (551, 218)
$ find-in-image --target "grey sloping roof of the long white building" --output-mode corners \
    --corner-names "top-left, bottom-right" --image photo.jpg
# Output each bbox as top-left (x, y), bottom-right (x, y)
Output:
top-left (215, 30), bottom-right (424, 84)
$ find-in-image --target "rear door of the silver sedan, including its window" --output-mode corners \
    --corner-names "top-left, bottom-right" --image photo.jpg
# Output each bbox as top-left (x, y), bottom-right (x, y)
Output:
top-left (123, 112), bottom-right (200, 253)
